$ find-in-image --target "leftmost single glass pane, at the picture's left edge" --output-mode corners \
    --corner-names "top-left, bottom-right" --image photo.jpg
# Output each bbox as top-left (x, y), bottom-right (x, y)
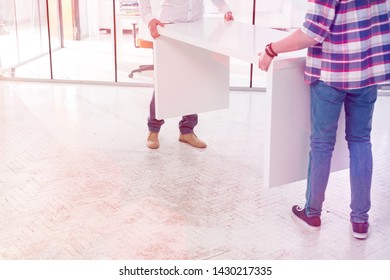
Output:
top-left (0, 0), bottom-right (59, 79)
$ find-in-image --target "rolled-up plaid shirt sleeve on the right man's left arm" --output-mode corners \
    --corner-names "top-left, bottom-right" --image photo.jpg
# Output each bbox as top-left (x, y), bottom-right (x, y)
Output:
top-left (301, 0), bottom-right (339, 42)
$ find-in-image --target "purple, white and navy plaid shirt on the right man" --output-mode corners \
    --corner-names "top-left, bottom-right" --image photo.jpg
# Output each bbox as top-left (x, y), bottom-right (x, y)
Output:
top-left (301, 0), bottom-right (390, 89)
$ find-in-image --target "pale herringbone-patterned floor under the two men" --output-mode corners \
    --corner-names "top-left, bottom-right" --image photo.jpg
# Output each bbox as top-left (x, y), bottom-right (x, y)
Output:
top-left (0, 81), bottom-right (390, 260)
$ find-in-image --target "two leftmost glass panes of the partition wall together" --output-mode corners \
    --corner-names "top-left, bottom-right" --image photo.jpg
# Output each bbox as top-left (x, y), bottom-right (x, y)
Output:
top-left (0, 0), bottom-right (117, 82)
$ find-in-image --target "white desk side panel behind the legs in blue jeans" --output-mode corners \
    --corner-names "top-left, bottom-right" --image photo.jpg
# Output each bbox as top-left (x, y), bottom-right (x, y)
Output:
top-left (264, 58), bottom-right (349, 187)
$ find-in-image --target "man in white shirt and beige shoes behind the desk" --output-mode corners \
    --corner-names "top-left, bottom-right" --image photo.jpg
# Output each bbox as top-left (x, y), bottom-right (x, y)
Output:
top-left (139, 0), bottom-right (234, 149)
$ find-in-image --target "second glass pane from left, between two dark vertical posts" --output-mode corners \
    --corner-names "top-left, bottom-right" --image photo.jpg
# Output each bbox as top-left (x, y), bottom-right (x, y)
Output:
top-left (52, 0), bottom-right (116, 82)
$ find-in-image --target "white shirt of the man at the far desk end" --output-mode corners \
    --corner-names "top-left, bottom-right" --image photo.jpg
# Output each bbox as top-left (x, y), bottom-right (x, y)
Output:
top-left (139, 0), bottom-right (230, 25)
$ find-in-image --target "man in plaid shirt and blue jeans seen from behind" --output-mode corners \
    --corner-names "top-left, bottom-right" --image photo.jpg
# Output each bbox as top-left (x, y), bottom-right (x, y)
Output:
top-left (259, 0), bottom-right (390, 239)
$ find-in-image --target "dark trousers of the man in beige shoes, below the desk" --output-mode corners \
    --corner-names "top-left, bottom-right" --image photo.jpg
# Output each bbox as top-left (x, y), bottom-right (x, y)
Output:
top-left (148, 91), bottom-right (198, 134)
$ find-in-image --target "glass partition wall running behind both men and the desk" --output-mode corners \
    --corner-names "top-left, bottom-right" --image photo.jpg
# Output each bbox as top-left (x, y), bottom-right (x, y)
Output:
top-left (0, 0), bottom-right (306, 88)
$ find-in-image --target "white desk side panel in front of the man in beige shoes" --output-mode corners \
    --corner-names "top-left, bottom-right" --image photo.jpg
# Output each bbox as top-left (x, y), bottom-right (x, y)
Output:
top-left (154, 36), bottom-right (229, 119)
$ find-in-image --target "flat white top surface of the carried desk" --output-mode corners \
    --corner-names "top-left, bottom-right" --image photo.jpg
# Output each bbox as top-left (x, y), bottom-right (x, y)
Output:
top-left (157, 18), bottom-right (306, 64)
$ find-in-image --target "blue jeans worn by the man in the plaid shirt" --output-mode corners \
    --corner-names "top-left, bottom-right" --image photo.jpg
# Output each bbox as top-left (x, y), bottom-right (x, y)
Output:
top-left (305, 81), bottom-right (377, 223)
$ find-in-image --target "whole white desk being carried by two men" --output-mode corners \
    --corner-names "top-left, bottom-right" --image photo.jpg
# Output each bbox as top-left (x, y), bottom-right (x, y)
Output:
top-left (154, 18), bottom-right (348, 187)
